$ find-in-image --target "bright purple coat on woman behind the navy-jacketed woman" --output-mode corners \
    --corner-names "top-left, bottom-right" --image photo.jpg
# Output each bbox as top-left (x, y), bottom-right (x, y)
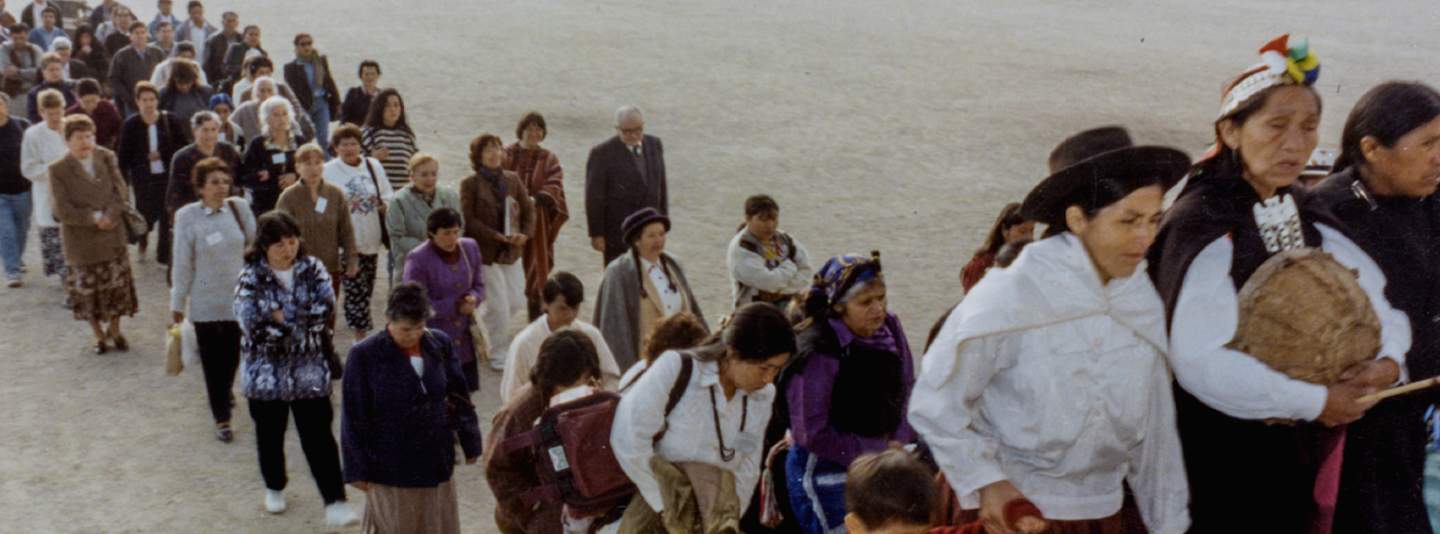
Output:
top-left (405, 237), bottom-right (485, 363)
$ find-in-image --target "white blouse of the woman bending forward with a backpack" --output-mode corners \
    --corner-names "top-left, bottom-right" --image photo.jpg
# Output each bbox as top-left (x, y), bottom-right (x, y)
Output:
top-left (611, 351), bottom-right (775, 514)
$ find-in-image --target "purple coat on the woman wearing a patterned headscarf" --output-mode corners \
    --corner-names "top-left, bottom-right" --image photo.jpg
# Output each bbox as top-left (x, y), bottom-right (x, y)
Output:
top-left (785, 314), bottom-right (916, 466)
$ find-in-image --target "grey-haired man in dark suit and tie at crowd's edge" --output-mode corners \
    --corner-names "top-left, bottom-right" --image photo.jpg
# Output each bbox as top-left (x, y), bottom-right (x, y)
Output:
top-left (585, 105), bottom-right (670, 265)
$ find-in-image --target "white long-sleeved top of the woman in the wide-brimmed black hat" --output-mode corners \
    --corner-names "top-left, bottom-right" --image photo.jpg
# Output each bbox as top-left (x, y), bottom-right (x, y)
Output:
top-left (910, 233), bottom-right (1189, 533)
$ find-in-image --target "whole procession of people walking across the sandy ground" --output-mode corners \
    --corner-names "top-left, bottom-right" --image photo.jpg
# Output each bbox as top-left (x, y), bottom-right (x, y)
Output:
top-left (0, 0), bottom-right (1440, 533)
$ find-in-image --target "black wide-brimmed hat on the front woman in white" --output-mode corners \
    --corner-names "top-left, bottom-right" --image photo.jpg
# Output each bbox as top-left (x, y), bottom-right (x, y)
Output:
top-left (1020, 127), bottom-right (1189, 225)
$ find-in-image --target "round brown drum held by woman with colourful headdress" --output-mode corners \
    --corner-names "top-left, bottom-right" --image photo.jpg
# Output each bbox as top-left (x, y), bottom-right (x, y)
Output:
top-left (1227, 249), bottom-right (1380, 386)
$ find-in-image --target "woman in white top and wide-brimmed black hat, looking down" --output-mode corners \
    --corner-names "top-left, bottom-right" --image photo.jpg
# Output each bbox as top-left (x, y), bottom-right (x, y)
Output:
top-left (910, 127), bottom-right (1189, 533)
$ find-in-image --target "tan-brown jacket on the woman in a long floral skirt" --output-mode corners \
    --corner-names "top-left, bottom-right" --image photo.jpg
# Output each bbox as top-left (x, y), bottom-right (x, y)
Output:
top-left (50, 147), bottom-right (130, 266)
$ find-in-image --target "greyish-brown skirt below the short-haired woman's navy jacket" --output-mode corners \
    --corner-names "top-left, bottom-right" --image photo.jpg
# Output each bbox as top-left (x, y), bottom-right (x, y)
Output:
top-left (364, 481), bottom-right (459, 534)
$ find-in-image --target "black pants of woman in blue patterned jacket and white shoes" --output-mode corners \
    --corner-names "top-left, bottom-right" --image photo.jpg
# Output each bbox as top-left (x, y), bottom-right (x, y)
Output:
top-left (251, 397), bottom-right (346, 505)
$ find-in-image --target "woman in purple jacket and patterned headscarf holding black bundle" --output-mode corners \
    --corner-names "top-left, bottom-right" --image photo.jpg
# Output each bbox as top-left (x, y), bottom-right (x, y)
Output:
top-left (783, 252), bottom-right (916, 533)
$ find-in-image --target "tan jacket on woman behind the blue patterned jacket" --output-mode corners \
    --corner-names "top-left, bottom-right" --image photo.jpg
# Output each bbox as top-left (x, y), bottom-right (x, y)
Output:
top-left (275, 181), bottom-right (360, 273)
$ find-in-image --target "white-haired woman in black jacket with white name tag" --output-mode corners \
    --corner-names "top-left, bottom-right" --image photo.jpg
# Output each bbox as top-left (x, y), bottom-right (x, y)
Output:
top-left (236, 95), bottom-right (310, 214)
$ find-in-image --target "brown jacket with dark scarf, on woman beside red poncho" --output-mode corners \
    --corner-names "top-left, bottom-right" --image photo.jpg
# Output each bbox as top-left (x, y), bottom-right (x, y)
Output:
top-left (459, 171), bottom-right (536, 265)
